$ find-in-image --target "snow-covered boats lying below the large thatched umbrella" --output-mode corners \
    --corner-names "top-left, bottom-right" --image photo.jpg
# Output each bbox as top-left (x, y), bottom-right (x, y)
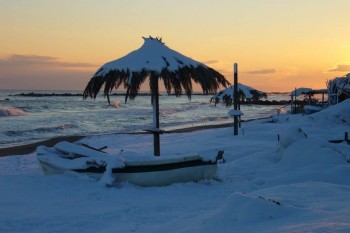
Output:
top-left (37, 142), bottom-right (223, 187)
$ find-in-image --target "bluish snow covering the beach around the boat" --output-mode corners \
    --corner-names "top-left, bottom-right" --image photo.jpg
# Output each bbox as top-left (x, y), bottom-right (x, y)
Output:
top-left (0, 100), bottom-right (350, 233)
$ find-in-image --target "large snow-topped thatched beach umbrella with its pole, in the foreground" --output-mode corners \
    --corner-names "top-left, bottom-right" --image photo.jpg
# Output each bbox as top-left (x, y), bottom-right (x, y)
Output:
top-left (83, 37), bottom-right (230, 156)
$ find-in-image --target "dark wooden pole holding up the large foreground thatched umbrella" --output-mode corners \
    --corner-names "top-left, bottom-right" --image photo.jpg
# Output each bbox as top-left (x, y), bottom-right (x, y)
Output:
top-left (151, 75), bottom-right (160, 156)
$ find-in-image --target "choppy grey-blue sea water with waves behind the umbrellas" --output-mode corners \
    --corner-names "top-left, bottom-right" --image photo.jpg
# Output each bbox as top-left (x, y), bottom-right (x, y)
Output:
top-left (0, 91), bottom-right (289, 148)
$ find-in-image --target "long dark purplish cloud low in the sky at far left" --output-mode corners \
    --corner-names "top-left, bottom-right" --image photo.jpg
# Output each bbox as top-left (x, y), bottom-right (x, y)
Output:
top-left (0, 54), bottom-right (96, 68)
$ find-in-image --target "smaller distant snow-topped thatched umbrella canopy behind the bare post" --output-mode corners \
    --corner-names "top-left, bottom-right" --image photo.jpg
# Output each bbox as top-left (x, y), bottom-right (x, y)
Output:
top-left (210, 83), bottom-right (267, 106)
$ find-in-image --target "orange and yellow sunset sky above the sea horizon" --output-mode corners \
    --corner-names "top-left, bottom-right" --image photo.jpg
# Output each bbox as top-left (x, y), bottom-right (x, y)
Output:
top-left (0, 0), bottom-right (350, 92)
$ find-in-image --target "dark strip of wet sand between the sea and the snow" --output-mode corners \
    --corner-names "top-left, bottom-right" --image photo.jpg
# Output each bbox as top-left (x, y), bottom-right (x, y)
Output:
top-left (0, 123), bottom-right (233, 157)
